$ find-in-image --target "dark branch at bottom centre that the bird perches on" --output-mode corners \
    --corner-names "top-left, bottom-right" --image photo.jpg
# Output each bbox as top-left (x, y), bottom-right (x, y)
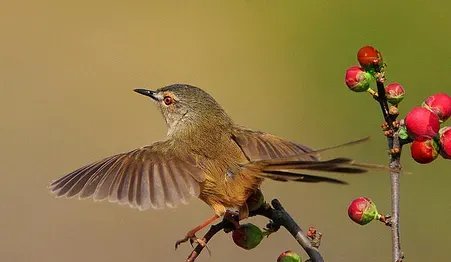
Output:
top-left (185, 199), bottom-right (324, 262)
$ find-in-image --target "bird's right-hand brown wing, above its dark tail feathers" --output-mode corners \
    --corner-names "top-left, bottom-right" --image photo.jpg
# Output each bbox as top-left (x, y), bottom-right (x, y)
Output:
top-left (232, 128), bottom-right (319, 162)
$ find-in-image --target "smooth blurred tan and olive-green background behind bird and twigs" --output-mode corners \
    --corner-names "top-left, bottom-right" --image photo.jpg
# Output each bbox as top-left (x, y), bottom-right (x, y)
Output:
top-left (0, 0), bottom-right (451, 262)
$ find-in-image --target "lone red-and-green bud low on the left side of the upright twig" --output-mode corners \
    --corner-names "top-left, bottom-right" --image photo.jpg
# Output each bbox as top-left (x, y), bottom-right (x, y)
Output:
top-left (348, 197), bottom-right (381, 225)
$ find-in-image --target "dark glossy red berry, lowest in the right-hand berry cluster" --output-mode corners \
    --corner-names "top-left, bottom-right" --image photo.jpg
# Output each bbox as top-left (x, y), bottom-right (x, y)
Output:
top-left (410, 137), bottom-right (438, 164)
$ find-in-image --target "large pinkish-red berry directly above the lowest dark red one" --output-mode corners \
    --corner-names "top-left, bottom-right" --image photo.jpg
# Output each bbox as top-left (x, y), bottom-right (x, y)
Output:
top-left (404, 107), bottom-right (440, 139)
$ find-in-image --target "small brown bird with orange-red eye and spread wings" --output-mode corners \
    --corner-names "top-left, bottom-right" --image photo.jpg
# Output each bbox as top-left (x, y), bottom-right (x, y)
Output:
top-left (49, 84), bottom-right (367, 248)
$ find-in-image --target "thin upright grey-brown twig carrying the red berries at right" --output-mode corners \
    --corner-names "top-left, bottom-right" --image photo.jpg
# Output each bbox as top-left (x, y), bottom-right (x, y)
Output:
top-left (376, 71), bottom-right (403, 262)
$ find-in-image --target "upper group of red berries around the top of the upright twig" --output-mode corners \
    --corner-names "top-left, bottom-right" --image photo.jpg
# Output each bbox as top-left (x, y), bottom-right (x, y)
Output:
top-left (345, 46), bottom-right (451, 164)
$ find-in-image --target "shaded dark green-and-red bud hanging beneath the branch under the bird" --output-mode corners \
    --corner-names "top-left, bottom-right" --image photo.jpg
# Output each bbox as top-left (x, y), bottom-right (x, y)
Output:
top-left (232, 223), bottom-right (264, 250)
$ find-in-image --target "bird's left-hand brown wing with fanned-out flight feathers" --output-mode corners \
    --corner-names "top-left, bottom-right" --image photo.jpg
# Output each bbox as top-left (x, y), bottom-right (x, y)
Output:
top-left (50, 140), bottom-right (204, 210)
